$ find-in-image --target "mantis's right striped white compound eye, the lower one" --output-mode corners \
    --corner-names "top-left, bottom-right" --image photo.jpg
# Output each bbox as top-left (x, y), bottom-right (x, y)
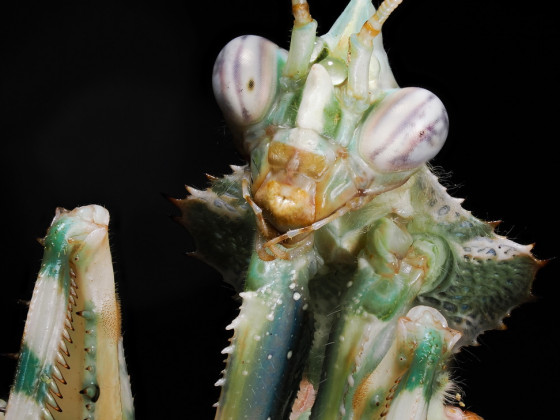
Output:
top-left (358, 88), bottom-right (449, 172)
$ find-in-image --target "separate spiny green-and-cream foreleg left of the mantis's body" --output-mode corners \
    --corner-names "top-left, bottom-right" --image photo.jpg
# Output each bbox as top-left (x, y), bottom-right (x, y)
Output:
top-left (0, 205), bottom-right (134, 420)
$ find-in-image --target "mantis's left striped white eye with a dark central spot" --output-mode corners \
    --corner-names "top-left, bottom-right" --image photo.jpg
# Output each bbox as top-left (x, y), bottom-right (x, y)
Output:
top-left (212, 35), bottom-right (281, 126)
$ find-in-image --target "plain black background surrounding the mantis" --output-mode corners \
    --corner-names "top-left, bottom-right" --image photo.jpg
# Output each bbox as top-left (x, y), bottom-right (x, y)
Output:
top-left (0, 0), bottom-right (560, 419)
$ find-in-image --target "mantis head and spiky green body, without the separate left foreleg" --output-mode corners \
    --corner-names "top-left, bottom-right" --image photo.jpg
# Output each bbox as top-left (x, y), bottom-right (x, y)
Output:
top-left (177, 0), bottom-right (539, 420)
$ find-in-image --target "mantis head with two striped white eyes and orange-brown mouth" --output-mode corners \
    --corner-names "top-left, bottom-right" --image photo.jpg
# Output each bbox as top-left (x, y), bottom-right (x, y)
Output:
top-left (213, 1), bottom-right (448, 236)
